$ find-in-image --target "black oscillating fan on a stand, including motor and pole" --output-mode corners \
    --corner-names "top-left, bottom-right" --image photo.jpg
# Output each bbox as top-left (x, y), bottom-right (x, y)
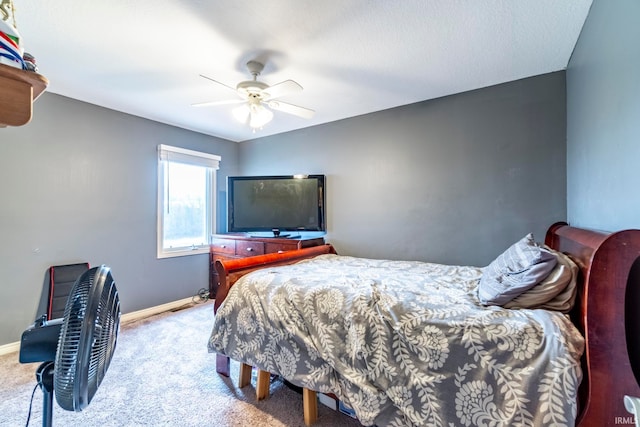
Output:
top-left (20, 265), bottom-right (120, 426)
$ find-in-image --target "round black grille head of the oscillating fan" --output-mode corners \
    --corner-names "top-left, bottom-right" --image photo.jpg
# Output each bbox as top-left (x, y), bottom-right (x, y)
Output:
top-left (54, 265), bottom-right (120, 412)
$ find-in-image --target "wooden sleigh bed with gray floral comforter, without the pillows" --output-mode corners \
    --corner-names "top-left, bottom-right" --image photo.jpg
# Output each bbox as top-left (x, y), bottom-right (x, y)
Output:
top-left (209, 223), bottom-right (640, 426)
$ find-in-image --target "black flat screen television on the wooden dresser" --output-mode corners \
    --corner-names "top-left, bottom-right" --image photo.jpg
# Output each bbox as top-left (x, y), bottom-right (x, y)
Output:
top-left (227, 175), bottom-right (326, 237)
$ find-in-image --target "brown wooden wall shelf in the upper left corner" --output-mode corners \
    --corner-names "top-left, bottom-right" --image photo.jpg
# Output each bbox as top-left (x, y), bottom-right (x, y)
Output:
top-left (0, 64), bottom-right (49, 127)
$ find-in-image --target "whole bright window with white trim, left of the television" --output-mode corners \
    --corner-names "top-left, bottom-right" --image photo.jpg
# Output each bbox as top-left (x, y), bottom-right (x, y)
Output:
top-left (158, 145), bottom-right (220, 258)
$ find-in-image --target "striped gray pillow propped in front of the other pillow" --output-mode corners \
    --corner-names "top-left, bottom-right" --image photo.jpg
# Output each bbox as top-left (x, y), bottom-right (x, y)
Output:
top-left (478, 233), bottom-right (558, 305)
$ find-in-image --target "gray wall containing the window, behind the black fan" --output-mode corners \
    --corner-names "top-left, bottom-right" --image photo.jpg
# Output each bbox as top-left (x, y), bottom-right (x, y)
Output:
top-left (0, 93), bottom-right (238, 345)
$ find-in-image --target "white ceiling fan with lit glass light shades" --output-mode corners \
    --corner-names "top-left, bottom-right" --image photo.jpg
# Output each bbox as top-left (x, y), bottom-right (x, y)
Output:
top-left (191, 61), bottom-right (315, 131)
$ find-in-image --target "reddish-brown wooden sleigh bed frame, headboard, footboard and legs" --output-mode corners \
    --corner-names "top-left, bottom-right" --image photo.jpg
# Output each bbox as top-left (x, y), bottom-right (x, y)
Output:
top-left (214, 222), bottom-right (640, 427)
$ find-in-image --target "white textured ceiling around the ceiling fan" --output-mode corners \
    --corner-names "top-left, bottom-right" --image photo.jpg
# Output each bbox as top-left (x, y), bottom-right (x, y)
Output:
top-left (14, 0), bottom-right (591, 141)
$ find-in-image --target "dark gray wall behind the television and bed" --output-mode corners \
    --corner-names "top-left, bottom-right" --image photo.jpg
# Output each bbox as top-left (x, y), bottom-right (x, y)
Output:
top-left (239, 72), bottom-right (566, 265)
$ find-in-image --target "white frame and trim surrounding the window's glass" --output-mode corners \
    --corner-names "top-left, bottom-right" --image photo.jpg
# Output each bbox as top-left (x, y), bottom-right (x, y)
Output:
top-left (156, 144), bottom-right (222, 259)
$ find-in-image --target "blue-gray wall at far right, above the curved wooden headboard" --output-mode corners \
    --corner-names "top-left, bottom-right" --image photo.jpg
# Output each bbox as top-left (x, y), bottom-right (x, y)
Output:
top-left (567, 0), bottom-right (640, 231)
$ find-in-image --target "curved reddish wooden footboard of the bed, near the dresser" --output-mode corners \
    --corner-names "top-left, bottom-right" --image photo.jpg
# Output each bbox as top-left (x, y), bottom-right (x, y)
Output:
top-left (213, 244), bottom-right (336, 376)
